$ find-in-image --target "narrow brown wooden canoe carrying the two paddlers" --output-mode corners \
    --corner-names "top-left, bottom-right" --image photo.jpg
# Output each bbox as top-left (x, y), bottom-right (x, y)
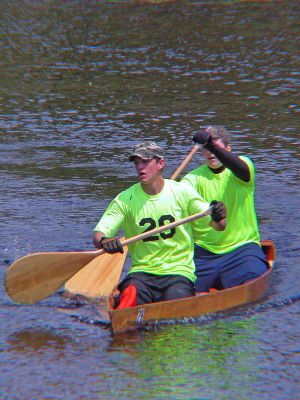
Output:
top-left (107, 240), bottom-right (276, 333)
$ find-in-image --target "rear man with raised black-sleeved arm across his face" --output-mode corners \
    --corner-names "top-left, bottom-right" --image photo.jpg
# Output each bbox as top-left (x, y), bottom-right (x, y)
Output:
top-left (182, 126), bottom-right (267, 292)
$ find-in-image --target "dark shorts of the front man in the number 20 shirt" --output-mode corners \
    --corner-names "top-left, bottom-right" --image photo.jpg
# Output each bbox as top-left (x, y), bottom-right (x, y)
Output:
top-left (118, 272), bottom-right (195, 305)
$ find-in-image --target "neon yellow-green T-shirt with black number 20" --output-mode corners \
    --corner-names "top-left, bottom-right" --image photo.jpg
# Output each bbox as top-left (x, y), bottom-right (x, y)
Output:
top-left (94, 179), bottom-right (211, 282)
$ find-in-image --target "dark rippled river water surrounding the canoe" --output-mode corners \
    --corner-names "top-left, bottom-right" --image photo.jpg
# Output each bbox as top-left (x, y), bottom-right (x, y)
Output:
top-left (0, 0), bottom-right (300, 400)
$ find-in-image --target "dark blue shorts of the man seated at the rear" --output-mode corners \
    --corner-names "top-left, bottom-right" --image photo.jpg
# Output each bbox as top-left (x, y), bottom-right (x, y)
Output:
top-left (194, 243), bottom-right (268, 292)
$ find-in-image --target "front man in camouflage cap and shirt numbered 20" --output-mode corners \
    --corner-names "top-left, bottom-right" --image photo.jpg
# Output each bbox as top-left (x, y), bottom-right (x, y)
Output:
top-left (93, 142), bottom-right (226, 308)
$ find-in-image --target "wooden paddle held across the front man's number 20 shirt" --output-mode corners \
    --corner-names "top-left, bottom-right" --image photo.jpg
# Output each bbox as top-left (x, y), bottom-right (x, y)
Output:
top-left (4, 207), bottom-right (212, 303)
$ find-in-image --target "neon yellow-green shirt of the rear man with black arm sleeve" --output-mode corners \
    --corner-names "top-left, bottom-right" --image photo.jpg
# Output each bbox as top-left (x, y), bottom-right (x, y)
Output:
top-left (182, 156), bottom-right (260, 254)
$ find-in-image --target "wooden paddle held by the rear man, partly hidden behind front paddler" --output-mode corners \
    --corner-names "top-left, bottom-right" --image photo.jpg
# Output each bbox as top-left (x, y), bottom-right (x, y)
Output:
top-left (65, 144), bottom-right (201, 299)
